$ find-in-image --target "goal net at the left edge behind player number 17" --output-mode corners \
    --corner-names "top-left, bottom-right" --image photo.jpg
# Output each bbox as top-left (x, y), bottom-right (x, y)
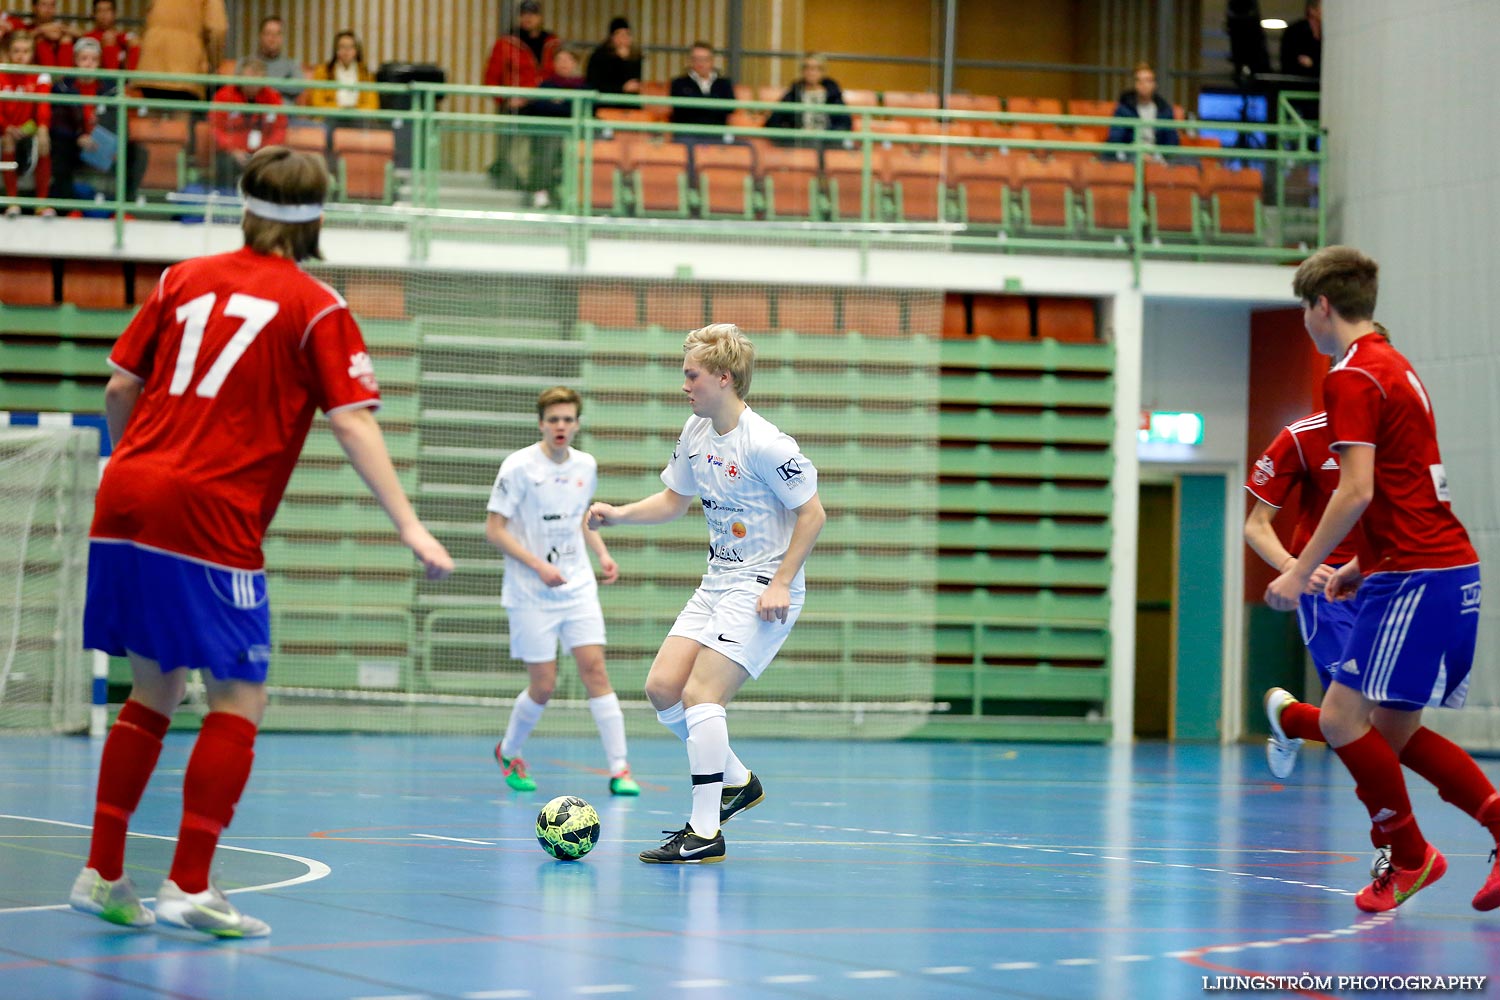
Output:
top-left (0, 427), bottom-right (99, 733)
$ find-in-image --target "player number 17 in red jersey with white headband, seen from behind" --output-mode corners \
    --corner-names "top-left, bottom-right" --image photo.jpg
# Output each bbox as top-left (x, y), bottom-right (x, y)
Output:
top-left (71, 147), bottom-right (453, 937)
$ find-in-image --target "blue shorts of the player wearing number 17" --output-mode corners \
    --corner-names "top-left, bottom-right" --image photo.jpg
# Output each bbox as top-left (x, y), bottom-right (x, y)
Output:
top-left (84, 538), bottom-right (272, 684)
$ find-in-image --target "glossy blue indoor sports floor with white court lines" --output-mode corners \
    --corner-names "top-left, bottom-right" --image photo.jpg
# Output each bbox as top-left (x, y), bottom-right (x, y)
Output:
top-left (0, 727), bottom-right (1500, 1000)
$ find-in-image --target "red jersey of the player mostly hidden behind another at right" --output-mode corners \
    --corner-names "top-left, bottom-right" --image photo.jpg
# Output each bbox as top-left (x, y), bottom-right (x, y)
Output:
top-left (1245, 414), bottom-right (1361, 565)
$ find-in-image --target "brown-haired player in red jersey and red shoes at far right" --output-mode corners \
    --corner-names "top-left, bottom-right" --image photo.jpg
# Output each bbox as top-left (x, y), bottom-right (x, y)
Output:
top-left (1266, 246), bottom-right (1500, 912)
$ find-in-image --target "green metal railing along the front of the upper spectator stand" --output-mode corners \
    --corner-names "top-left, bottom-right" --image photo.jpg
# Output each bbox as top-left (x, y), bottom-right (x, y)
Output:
top-left (0, 66), bottom-right (1326, 271)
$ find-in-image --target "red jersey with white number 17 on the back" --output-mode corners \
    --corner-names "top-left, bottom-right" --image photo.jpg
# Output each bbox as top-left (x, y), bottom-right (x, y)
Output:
top-left (90, 249), bottom-right (380, 570)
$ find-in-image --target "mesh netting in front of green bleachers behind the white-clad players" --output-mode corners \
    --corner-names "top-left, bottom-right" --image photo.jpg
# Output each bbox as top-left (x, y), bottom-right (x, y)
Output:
top-left (266, 268), bottom-right (942, 738)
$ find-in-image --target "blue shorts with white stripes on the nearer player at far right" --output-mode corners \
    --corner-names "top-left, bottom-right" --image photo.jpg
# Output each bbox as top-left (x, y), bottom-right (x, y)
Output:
top-left (1334, 565), bottom-right (1481, 709)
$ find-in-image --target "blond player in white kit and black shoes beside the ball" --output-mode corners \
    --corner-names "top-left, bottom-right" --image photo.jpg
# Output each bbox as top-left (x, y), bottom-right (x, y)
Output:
top-left (588, 322), bottom-right (827, 864)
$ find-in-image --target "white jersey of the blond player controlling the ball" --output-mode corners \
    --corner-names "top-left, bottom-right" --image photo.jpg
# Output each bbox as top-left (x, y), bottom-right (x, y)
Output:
top-left (662, 406), bottom-right (818, 592)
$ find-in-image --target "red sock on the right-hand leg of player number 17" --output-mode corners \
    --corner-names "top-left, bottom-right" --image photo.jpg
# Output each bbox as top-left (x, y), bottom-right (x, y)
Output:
top-left (168, 712), bottom-right (255, 892)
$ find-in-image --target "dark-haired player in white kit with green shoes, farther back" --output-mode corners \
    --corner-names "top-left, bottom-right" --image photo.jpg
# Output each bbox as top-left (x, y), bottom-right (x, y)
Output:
top-left (485, 385), bottom-right (641, 795)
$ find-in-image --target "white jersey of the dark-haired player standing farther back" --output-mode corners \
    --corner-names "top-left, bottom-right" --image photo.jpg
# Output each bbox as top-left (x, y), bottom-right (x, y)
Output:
top-left (488, 441), bottom-right (599, 607)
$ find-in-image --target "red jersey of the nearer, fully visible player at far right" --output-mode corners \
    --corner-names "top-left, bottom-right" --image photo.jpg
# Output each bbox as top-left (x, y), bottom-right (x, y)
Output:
top-left (1323, 333), bottom-right (1479, 573)
